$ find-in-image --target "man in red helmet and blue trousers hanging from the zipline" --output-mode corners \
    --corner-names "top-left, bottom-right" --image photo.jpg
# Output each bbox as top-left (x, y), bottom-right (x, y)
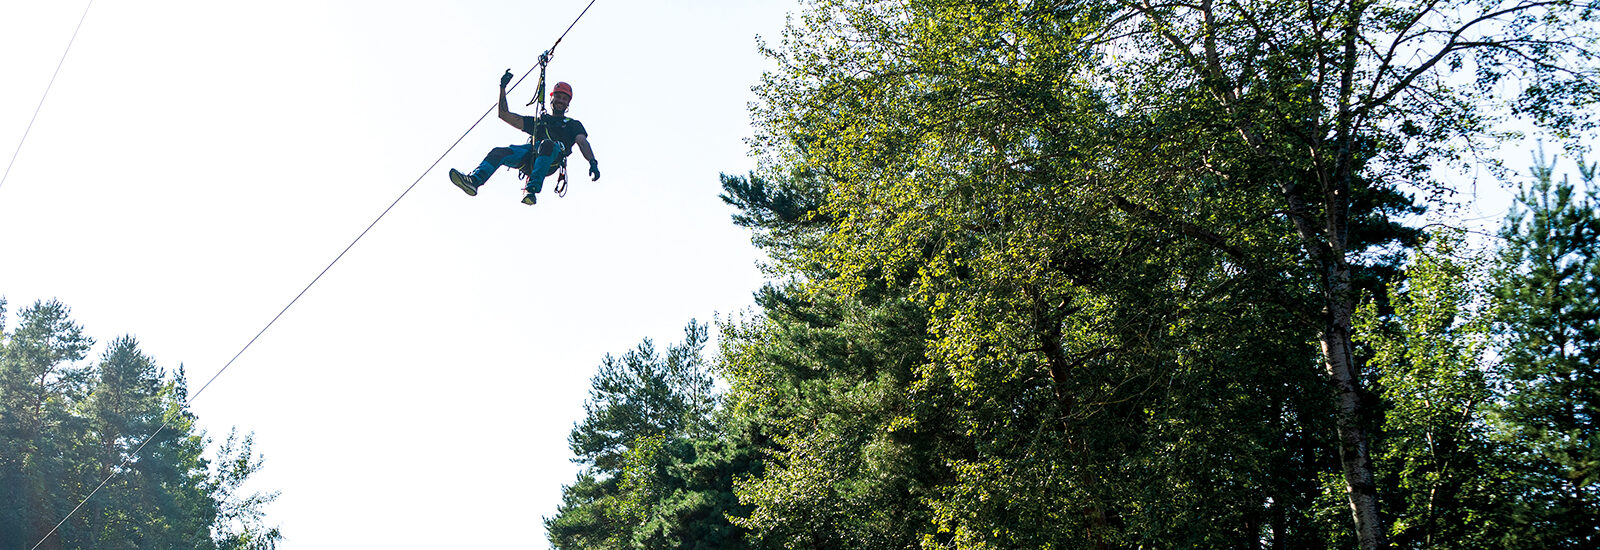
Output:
top-left (450, 70), bottom-right (600, 205)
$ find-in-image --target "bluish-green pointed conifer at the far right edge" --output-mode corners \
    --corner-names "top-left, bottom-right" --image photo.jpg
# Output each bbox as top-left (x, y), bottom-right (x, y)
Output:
top-left (1494, 152), bottom-right (1600, 548)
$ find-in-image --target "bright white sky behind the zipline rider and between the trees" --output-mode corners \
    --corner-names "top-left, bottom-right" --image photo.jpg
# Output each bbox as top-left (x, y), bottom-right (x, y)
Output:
top-left (0, 0), bottom-right (797, 548)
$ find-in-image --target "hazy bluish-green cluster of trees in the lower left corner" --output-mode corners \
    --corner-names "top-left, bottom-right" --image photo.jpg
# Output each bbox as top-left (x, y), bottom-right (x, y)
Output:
top-left (0, 301), bottom-right (282, 550)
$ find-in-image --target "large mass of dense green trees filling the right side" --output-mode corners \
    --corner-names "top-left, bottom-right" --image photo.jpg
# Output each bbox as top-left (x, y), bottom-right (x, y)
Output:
top-left (552, 0), bottom-right (1600, 548)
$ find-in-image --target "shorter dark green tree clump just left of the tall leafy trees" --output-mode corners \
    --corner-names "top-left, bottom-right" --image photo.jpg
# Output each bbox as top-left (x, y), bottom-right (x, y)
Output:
top-left (544, 321), bottom-right (750, 548)
